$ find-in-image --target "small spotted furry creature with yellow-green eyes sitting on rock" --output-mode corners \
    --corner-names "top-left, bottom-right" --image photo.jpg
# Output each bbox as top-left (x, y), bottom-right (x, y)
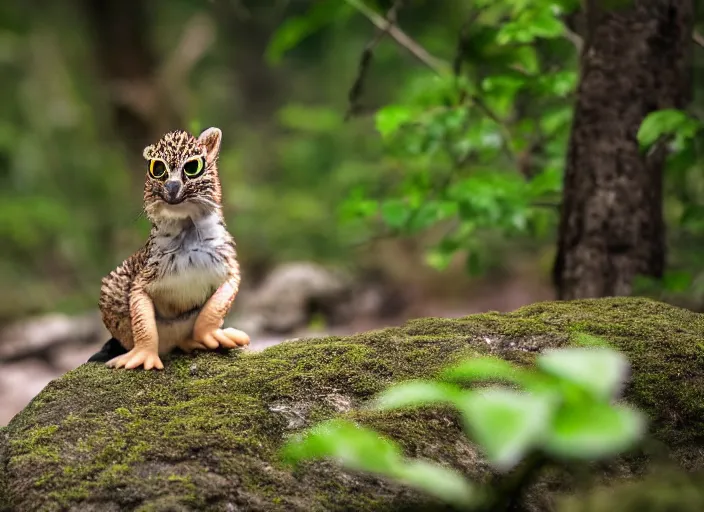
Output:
top-left (91, 128), bottom-right (249, 370)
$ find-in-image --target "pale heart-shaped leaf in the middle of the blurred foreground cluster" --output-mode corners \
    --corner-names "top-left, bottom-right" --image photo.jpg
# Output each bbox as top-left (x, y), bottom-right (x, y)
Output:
top-left (461, 388), bottom-right (554, 471)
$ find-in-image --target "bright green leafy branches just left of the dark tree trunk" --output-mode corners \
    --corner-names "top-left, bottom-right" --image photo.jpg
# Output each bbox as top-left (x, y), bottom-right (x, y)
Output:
top-left (332, 1), bottom-right (577, 274)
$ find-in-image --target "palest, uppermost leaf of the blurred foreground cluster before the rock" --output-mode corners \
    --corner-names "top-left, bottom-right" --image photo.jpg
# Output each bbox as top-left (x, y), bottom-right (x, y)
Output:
top-left (536, 347), bottom-right (629, 400)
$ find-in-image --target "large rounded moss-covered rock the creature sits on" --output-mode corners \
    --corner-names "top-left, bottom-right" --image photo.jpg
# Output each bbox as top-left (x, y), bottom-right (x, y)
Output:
top-left (0, 299), bottom-right (704, 511)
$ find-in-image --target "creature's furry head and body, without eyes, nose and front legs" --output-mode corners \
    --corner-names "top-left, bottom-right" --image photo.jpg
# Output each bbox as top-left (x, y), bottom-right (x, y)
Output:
top-left (99, 128), bottom-right (239, 354)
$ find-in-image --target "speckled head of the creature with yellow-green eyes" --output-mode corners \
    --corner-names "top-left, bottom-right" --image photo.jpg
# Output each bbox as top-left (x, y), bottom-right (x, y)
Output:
top-left (143, 128), bottom-right (227, 222)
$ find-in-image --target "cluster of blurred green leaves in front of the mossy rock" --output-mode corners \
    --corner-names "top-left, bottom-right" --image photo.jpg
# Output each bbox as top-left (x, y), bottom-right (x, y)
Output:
top-left (282, 342), bottom-right (646, 506)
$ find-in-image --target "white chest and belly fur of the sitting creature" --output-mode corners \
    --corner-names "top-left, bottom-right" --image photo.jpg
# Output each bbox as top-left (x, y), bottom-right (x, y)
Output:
top-left (146, 215), bottom-right (228, 317)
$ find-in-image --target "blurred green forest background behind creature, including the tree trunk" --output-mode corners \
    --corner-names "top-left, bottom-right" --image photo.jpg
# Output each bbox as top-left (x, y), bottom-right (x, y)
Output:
top-left (0, 0), bottom-right (704, 323)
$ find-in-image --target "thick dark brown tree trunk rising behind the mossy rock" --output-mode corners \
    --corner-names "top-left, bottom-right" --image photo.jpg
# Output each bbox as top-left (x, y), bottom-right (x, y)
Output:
top-left (553, 0), bottom-right (694, 299)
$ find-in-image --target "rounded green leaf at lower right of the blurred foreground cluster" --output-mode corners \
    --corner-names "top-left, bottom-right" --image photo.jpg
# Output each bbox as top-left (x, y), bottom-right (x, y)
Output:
top-left (545, 402), bottom-right (646, 460)
